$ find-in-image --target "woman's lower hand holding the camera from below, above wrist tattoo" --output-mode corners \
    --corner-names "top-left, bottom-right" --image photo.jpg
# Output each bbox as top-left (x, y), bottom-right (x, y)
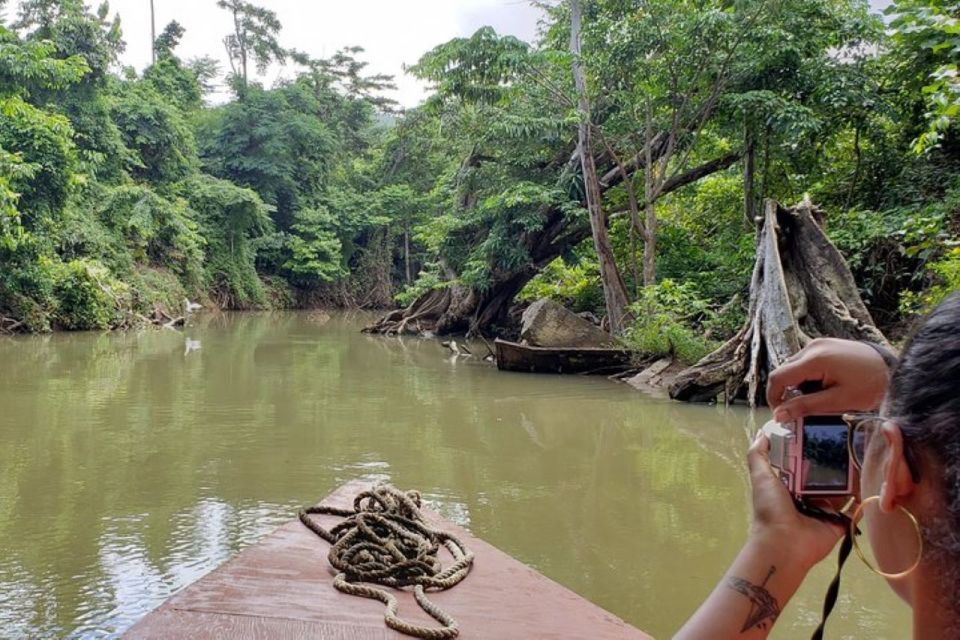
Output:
top-left (747, 433), bottom-right (844, 573)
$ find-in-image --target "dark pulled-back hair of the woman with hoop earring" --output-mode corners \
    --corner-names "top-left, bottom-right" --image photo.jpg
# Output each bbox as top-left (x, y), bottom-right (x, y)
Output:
top-left (886, 293), bottom-right (960, 596)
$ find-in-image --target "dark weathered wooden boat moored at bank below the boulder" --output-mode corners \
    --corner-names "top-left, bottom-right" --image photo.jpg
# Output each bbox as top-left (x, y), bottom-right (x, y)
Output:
top-left (494, 340), bottom-right (631, 375)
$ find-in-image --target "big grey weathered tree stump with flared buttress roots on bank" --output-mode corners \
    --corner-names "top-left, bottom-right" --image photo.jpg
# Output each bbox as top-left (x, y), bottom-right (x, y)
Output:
top-left (670, 200), bottom-right (886, 407)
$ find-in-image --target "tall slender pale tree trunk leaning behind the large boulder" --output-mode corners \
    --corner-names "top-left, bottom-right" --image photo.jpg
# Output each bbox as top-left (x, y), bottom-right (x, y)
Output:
top-left (570, 0), bottom-right (629, 335)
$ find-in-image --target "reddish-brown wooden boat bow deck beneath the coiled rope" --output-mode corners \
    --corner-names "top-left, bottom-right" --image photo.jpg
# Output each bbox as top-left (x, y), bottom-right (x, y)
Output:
top-left (124, 484), bottom-right (649, 640)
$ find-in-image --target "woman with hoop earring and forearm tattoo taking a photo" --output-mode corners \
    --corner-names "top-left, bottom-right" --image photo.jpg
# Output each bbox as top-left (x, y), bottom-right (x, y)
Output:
top-left (675, 294), bottom-right (960, 640)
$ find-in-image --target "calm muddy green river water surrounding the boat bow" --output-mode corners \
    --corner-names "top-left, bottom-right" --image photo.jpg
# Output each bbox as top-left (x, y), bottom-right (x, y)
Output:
top-left (0, 313), bottom-right (909, 639)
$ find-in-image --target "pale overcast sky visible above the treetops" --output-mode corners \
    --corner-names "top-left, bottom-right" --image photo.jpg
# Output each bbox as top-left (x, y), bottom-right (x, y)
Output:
top-left (7, 0), bottom-right (890, 107)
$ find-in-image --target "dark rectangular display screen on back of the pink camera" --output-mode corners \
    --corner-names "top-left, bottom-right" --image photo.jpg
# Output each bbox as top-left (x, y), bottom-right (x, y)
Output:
top-left (803, 416), bottom-right (850, 491)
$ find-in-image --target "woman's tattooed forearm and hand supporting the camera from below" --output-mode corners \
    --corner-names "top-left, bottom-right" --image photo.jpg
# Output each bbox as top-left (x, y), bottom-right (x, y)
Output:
top-left (674, 433), bottom-right (843, 640)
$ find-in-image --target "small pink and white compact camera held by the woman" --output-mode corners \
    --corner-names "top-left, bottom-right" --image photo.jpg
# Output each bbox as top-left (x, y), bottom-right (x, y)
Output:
top-left (763, 416), bottom-right (855, 499)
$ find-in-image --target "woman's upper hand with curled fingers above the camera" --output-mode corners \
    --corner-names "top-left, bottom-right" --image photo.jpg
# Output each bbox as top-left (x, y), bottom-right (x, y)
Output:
top-left (767, 338), bottom-right (890, 422)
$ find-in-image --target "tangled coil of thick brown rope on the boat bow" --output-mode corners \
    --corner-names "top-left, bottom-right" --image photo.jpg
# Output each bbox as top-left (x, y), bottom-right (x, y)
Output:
top-left (300, 484), bottom-right (473, 640)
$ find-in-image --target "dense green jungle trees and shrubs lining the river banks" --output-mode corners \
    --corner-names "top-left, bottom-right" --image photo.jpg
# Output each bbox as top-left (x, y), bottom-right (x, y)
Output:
top-left (0, 0), bottom-right (960, 350)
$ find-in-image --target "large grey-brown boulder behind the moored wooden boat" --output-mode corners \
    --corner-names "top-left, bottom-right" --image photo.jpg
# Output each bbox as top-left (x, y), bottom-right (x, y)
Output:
top-left (520, 298), bottom-right (620, 348)
